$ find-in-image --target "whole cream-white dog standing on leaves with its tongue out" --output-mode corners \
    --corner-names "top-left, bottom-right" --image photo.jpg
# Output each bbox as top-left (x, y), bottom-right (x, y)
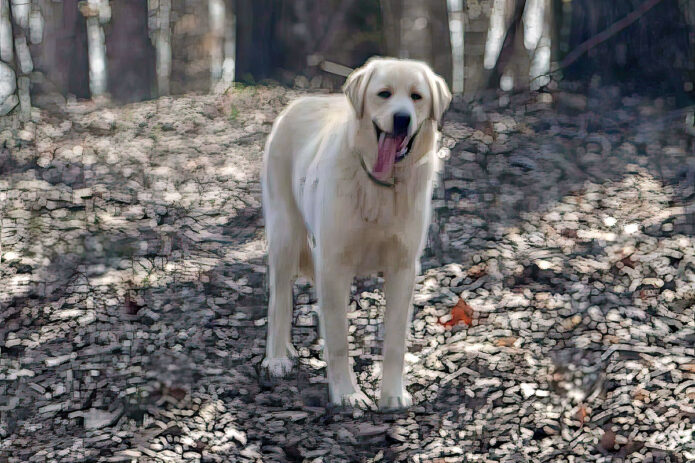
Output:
top-left (262, 58), bottom-right (451, 409)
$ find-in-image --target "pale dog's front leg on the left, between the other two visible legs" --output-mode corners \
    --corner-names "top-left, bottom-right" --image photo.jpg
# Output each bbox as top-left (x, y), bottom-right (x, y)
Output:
top-left (316, 265), bottom-right (373, 408)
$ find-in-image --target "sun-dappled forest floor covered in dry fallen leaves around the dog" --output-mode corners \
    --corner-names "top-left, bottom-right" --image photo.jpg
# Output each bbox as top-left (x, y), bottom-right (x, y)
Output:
top-left (0, 87), bottom-right (695, 463)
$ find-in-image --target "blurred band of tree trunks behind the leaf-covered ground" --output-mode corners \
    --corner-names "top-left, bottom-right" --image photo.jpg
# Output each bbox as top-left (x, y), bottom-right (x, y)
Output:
top-left (0, 0), bottom-right (695, 115)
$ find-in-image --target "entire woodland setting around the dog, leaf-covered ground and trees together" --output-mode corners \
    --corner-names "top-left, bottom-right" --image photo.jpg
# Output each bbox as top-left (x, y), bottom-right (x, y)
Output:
top-left (0, 0), bottom-right (695, 463)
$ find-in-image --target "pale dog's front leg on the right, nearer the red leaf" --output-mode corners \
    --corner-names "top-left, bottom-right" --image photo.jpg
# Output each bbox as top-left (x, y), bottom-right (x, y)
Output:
top-left (379, 263), bottom-right (415, 409)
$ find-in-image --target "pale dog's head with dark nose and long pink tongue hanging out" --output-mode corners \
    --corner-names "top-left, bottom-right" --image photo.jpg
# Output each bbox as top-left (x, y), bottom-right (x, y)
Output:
top-left (343, 58), bottom-right (451, 179)
